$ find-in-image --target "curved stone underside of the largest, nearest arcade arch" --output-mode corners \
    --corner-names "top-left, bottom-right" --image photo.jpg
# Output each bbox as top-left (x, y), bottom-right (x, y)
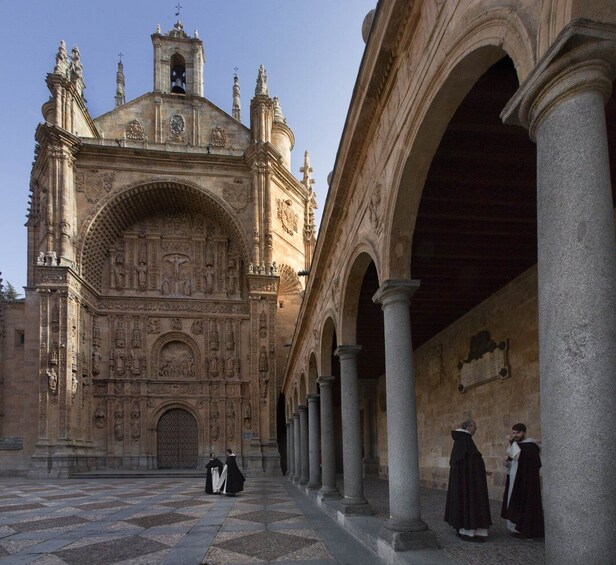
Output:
top-left (382, 6), bottom-right (535, 279)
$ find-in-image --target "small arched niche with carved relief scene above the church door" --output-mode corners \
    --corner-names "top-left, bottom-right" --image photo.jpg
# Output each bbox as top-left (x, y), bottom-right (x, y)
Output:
top-left (149, 332), bottom-right (203, 381)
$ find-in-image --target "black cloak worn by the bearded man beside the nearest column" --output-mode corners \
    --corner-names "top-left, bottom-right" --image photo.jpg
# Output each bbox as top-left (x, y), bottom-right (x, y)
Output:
top-left (501, 441), bottom-right (545, 538)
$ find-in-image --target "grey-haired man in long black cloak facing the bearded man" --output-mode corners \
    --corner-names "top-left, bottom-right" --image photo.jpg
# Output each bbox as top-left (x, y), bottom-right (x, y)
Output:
top-left (445, 420), bottom-right (492, 541)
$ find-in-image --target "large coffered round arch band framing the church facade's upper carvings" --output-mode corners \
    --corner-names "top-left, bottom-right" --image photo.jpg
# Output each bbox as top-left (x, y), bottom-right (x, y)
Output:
top-left (77, 179), bottom-right (249, 291)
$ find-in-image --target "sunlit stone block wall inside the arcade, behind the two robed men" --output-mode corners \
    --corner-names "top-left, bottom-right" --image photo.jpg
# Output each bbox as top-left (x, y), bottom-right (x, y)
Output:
top-left (377, 268), bottom-right (541, 499)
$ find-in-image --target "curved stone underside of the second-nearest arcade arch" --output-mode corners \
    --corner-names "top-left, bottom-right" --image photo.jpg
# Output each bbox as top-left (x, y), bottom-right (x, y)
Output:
top-left (338, 243), bottom-right (381, 345)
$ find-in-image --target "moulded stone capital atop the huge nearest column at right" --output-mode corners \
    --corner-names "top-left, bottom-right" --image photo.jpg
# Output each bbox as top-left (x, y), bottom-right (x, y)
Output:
top-left (501, 20), bottom-right (616, 140)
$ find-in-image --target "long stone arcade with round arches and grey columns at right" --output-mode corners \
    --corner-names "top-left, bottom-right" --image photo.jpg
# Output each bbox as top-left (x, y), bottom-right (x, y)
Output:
top-left (283, 0), bottom-right (616, 564)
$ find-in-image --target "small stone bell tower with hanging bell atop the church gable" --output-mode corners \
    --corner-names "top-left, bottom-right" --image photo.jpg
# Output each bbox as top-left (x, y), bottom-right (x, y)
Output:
top-left (152, 20), bottom-right (205, 97)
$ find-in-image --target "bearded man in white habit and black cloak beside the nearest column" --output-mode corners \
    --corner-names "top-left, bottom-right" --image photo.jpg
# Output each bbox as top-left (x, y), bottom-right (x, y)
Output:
top-left (501, 424), bottom-right (545, 539)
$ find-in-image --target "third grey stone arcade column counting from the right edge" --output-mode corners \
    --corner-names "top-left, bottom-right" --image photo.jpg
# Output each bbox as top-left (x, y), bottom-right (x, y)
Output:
top-left (335, 345), bottom-right (372, 514)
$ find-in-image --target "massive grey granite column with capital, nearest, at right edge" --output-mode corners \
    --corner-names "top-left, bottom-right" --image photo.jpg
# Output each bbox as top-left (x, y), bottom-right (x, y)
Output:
top-left (503, 36), bottom-right (616, 564)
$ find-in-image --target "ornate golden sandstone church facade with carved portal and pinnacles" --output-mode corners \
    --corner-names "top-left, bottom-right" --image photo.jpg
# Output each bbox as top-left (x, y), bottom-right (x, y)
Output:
top-left (0, 21), bottom-right (316, 478)
